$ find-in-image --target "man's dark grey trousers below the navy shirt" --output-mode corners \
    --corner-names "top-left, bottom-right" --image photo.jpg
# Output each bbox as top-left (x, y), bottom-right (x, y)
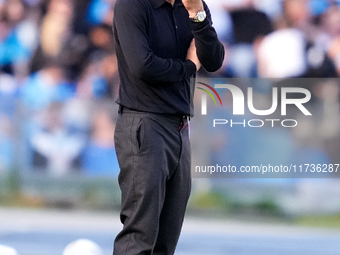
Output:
top-left (113, 108), bottom-right (191, 255)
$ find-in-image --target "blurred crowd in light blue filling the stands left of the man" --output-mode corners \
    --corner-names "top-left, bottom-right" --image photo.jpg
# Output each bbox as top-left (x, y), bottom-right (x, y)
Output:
top-left (0, 0), bottom-right (118, 176)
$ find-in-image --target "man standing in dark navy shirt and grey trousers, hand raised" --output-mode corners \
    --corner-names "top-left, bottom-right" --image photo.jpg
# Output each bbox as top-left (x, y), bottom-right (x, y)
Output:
top-left (113, 0), bottom-right (224, 255)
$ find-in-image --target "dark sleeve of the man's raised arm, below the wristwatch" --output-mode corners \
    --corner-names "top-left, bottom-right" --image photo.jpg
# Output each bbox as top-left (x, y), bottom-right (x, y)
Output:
top-left (191, 2), bottom-right (224, 72)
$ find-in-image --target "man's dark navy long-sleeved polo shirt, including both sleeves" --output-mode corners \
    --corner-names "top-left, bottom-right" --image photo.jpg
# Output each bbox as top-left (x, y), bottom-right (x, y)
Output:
top-left (113, 0), bottom-right (224, 115)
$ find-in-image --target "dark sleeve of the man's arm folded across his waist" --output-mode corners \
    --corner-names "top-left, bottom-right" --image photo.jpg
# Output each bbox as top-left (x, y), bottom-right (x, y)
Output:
top-left (113, 0), bottom-right (196, 83)
